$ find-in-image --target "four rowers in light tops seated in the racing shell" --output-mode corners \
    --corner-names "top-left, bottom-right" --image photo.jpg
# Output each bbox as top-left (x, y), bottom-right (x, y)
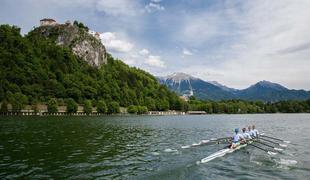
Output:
top-left (230, 125), bottom-right (259, 149)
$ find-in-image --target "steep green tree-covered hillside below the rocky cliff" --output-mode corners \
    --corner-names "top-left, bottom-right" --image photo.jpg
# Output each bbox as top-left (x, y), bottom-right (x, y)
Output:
top-left (0, 25), bottom-right (184, 110)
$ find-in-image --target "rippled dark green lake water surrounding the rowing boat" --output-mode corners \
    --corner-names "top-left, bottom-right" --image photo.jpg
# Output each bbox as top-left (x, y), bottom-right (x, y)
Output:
top-left (0, 114), bottom-right (310, 179)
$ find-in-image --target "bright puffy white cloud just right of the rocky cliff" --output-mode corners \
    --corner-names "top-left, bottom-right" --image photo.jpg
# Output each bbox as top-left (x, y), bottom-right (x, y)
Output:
top-left (100, 32), bottom-right (134, 53)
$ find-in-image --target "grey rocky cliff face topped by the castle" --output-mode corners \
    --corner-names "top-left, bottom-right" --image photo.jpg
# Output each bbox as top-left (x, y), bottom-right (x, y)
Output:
top-left (35, 24), bottom-right (107, 67)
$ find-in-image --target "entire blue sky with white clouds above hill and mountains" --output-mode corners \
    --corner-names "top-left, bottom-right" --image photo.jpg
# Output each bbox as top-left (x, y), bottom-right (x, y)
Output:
top-left (0, 0), bottom-right (310, 90)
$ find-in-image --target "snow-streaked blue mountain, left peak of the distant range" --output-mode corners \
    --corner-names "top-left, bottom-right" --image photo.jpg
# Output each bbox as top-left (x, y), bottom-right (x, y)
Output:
top-left (157, 73), bottom-right (234, 100)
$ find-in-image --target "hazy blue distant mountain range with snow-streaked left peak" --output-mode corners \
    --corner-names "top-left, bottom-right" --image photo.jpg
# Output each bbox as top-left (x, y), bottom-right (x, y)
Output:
top-left (157, 73), bottom-right (310, 102)
